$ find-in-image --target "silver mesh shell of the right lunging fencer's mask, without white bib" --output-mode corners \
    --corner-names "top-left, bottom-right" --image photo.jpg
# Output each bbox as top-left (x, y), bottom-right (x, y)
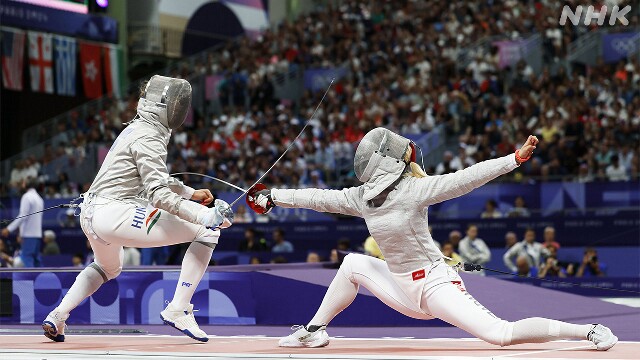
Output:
top-left (353, 128), bottom-right (411, 183)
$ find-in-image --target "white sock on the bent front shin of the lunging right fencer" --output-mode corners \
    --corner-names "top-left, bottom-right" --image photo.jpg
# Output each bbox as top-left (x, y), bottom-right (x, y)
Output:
top-left (307, 264), bottom-right (358, 329)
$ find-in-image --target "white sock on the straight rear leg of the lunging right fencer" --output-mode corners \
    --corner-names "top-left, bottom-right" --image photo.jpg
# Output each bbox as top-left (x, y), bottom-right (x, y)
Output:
top-left (510, 318), bottom-right (593, 345)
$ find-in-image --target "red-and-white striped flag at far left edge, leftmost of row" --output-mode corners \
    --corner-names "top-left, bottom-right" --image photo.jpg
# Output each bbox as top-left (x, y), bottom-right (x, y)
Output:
top-left (2, 28), bottom-right (25, 91)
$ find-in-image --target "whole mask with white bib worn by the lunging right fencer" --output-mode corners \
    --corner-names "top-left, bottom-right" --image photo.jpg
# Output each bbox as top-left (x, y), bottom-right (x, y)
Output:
top-left (353, 128), bottom-right (415, 201)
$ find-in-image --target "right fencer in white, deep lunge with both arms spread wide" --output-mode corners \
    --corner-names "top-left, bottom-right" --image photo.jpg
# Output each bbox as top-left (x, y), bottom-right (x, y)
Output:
top-left (248, 128), bottom-right (618, 350)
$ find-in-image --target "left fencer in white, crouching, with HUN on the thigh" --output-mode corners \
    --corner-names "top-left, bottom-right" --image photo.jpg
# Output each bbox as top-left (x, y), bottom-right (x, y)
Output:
top-left (42, 75), bottom-right (233, 342)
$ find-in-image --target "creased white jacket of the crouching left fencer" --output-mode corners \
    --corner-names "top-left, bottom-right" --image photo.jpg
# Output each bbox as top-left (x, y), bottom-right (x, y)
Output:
top-left (87, 119), bottom-right (204, 223)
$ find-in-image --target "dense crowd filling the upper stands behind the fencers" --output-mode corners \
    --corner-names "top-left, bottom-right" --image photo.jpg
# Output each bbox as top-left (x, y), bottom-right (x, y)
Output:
top-left (2, 1), bottom-right (640, 197)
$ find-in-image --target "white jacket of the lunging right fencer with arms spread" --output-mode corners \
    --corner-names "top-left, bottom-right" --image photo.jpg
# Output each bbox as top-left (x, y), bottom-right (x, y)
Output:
top-left (271, 154), bottom-right (518, 274)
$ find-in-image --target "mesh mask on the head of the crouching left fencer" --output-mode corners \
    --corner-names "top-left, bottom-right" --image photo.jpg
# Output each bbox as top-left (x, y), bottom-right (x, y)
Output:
top-left (138, 75), bottom-right (191, 129)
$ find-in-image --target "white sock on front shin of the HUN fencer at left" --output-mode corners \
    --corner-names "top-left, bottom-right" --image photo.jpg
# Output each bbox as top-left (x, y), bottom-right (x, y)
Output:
top-left (171, 241), bottom-right (213, 309)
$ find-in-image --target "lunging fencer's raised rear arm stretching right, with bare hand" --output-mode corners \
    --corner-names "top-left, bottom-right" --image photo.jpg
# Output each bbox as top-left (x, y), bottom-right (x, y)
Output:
top-left (415, 136), bottom-right (538, 206)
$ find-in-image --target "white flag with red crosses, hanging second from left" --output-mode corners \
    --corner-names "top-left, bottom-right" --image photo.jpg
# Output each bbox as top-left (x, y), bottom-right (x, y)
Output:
top-left (27, 31), bottom-right (53, 94)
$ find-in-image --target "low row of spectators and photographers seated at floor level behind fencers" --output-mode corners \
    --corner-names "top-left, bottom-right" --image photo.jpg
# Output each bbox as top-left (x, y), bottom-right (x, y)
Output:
top-left (0, 219), bottom-right (607, 278)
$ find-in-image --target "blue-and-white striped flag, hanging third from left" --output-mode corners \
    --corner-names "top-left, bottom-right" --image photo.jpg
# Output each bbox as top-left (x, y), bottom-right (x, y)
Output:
top-left (53, 35), bottom-right (77, 96)
